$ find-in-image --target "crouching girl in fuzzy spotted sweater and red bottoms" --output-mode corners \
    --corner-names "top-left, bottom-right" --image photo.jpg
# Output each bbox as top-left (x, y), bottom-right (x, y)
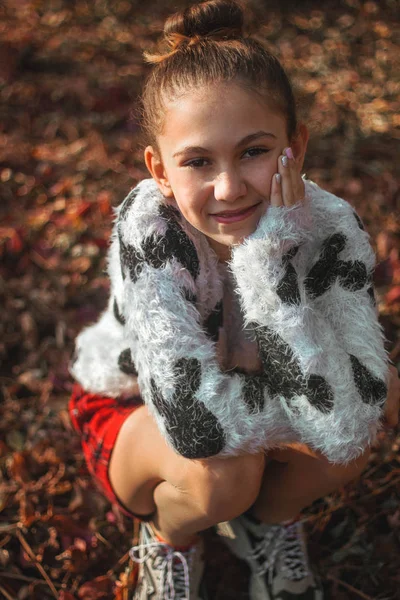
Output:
top-left (70, 0), bottom-right (398, 600)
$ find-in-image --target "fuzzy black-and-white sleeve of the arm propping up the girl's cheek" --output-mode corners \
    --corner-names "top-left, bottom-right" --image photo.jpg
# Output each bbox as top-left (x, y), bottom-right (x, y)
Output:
top-left (230, 182), bottom-right (388, 463)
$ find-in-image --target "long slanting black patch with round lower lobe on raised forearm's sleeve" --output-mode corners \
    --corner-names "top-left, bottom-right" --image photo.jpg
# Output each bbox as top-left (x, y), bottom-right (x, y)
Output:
top-left (254, 326), bottom-right (334, 414)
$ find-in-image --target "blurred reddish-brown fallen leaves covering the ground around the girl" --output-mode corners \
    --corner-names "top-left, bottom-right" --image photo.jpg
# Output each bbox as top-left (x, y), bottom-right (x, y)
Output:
top-left (0, 0), bottom-right (400, 600)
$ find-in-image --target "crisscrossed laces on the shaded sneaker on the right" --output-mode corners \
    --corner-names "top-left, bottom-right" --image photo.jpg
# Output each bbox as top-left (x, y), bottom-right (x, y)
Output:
top-left (249, 523), bottom-right (309, 581)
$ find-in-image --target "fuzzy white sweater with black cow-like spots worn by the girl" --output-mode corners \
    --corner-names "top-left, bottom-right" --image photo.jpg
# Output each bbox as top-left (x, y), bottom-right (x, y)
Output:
top-left (71, 179), bottom-right (388, 463)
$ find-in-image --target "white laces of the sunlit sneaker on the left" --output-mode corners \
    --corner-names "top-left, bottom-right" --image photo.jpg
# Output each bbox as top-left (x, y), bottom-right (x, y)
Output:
top-left (129, 542), bottom-right (194, 600)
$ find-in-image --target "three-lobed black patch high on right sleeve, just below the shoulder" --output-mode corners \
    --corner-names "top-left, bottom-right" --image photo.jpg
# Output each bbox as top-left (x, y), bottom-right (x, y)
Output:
top-left (304, 233), bottom-right (368, 298)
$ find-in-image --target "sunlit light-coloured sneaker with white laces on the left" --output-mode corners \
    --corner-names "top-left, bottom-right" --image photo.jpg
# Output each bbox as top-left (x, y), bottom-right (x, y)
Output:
top-left (129, 522), bottom-right (207, 600)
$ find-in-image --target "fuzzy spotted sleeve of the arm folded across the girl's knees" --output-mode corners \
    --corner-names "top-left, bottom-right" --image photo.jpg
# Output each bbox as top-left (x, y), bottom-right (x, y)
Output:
top-left (114, 178), bottom-right (298, 458)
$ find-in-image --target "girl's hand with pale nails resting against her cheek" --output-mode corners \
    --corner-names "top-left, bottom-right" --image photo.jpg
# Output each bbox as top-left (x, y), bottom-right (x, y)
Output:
top-left (270, 148), bottom-right (305, 206)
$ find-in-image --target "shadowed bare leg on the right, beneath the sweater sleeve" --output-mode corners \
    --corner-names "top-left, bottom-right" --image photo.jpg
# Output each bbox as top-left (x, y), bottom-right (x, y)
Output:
top-left (253, 444), bottom-right (370, 523)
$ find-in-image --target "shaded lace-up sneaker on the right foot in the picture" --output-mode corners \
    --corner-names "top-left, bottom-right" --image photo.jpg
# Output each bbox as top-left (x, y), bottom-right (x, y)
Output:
top-left (217, 515), bottom-right (323, 600)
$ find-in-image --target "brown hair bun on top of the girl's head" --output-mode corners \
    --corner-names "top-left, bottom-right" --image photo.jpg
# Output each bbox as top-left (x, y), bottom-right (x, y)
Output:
top-left (164, 0), bottom-right (244, 39)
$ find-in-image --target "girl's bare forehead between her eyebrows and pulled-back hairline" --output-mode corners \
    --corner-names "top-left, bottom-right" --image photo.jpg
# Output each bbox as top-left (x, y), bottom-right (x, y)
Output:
top-left (159, 82), bottom-right (286, 145)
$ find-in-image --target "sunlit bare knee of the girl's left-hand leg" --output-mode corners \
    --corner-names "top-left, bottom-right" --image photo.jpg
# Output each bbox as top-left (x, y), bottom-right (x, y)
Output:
top-left (191, 453), bottom-right (265, 524)
